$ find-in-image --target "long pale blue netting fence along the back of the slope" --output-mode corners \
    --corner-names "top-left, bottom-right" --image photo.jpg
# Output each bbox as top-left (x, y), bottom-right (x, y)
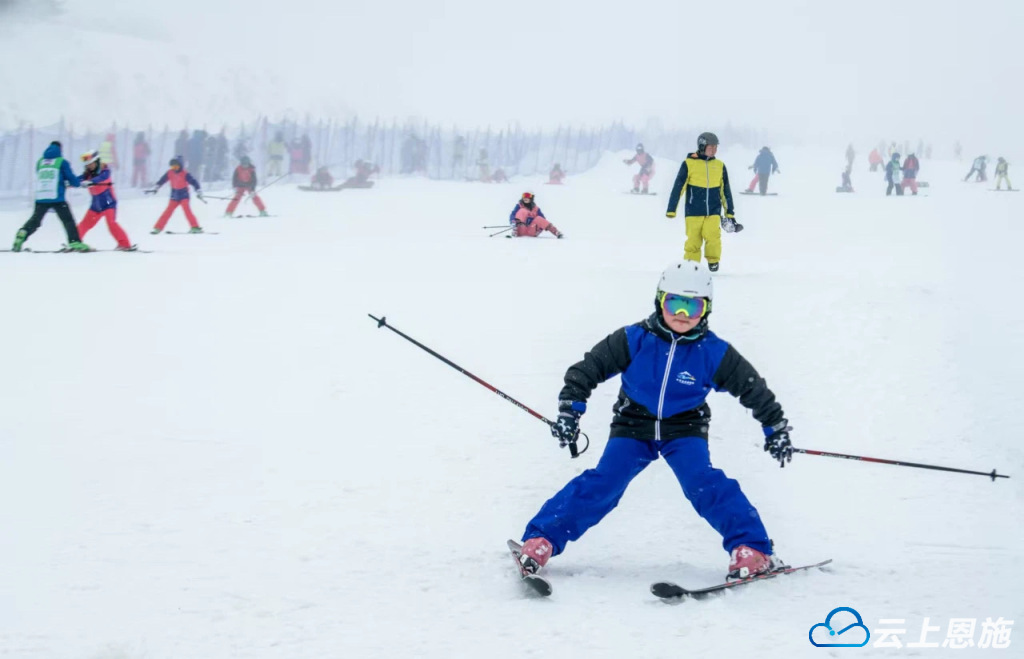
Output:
top-left (0, 118), bottom-right (759, 197)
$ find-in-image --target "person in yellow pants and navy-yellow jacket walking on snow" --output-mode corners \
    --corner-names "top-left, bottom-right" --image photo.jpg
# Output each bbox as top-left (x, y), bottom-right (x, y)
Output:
top-left (665, 133), bottom-right (743, 272)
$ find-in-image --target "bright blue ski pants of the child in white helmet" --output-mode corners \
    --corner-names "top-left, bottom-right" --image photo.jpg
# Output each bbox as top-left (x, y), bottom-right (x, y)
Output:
top-left (522, 437), bottom-right (771, 556)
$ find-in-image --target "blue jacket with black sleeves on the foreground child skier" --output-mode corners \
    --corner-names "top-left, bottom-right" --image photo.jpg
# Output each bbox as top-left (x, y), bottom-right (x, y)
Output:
top-left (558, 313), bottom-right (784, 440)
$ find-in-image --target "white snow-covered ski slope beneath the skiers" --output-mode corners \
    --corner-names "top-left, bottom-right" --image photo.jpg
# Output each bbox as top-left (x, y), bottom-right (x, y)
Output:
top-left (0, 150), bottom-right (1024, 659)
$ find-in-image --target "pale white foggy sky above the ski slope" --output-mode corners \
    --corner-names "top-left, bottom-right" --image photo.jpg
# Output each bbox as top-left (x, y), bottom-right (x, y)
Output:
top-left (4, 0), bottom-right (1024, 152)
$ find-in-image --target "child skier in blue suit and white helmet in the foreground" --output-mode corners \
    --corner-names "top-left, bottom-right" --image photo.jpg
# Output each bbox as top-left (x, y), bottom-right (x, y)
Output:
top-left (520, 261), bottom-right (793, 579)
